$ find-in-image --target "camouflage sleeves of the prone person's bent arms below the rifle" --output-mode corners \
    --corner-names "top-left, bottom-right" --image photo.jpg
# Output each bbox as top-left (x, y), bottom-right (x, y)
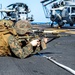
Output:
top-left (8, 35), bottom-right (46, 58)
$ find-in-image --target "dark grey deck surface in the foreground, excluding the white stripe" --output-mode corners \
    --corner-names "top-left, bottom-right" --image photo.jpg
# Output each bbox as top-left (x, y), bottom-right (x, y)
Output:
top-left (0, 27), bottom-right (75, 75)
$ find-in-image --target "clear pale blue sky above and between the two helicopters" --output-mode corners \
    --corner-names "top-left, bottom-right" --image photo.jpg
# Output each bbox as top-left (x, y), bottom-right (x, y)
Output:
top-left (0, 0), bottom-right (50, 22)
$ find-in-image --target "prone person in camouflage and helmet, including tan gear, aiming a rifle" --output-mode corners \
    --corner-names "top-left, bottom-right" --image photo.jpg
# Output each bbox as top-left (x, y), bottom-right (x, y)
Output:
top-left (0, 20), bottom-right (47, 58)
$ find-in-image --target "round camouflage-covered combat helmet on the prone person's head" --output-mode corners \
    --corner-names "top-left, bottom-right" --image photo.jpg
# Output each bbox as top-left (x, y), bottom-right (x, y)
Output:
top-left (14, 20), bottom-right (32, 35)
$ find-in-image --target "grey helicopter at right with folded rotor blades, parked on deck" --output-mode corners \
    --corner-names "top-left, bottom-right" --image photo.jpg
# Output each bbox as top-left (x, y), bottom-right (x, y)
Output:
top-left (41, 0), bottom-right (75, 28)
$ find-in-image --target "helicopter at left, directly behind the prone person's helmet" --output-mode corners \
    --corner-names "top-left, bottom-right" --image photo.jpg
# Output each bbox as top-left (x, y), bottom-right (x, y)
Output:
top-left (0, 3), bottom-right (34, 22)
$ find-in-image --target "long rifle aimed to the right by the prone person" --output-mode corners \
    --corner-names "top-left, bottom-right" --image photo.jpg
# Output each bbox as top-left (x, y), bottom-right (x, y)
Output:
top-left (18, 30), bottom-right (69, 42)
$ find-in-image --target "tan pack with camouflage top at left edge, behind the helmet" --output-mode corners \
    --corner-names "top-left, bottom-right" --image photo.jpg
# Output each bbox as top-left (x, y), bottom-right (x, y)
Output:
top-left (0, 20), bottom-right (16, 56)
